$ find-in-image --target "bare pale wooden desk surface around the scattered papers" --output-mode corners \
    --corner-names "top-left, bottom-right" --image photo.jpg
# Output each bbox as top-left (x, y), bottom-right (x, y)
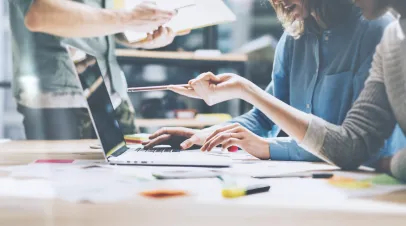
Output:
top-left (0, 140), bottom-right (406, 226)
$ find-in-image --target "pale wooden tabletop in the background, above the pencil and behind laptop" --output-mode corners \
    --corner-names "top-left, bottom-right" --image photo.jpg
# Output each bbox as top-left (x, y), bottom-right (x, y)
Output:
top-left (116, 49), bottom-right (248, 62)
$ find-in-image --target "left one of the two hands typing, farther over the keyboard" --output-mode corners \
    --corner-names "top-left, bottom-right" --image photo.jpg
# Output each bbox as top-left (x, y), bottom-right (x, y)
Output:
top-left (143, 127), bottom-right (209, 150)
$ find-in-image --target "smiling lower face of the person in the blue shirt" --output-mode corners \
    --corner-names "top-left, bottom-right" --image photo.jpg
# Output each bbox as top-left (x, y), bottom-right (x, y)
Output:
top-left (272, 0), bottom-right (309, 20)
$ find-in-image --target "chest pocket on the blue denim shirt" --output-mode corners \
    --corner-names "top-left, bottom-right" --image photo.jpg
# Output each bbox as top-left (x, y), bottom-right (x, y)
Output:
top-left (314, 71), bottom-right (354, 124)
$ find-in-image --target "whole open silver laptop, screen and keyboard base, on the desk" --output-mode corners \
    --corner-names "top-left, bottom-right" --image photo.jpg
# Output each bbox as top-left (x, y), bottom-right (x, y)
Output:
top-left (72, 49), bottom-right (232, 167)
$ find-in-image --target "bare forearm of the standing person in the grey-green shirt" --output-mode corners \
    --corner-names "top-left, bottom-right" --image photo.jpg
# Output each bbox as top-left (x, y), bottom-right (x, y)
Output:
top-left (25, 0), bottom-right (128, 37)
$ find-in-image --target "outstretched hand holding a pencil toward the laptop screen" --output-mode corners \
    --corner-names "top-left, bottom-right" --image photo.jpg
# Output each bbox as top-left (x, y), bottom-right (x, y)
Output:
top-left (169, 72), bottom-right (252, 106)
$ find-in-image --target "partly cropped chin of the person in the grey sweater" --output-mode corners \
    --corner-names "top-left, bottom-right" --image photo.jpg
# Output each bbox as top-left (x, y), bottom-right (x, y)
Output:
top-left (353, 0), bottom-right (389, 20)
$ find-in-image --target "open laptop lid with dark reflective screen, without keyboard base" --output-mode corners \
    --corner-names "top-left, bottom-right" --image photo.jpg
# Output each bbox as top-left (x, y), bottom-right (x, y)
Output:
top-left (71, 49), bottom-right (128, 158)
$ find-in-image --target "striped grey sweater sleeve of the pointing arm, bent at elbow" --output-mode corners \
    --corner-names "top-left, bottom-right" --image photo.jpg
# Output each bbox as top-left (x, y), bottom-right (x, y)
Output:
top-left (301, 80), bottom-right (396, 170)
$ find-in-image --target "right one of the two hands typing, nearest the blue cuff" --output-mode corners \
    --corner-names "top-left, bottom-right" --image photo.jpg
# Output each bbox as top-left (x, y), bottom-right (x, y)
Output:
top-left (201, 124), bottom-right (270, 159)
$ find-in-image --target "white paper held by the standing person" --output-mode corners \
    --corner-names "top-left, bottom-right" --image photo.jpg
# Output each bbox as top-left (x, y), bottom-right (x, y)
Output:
top-left (117, 0), bottom-right (236, 42)
